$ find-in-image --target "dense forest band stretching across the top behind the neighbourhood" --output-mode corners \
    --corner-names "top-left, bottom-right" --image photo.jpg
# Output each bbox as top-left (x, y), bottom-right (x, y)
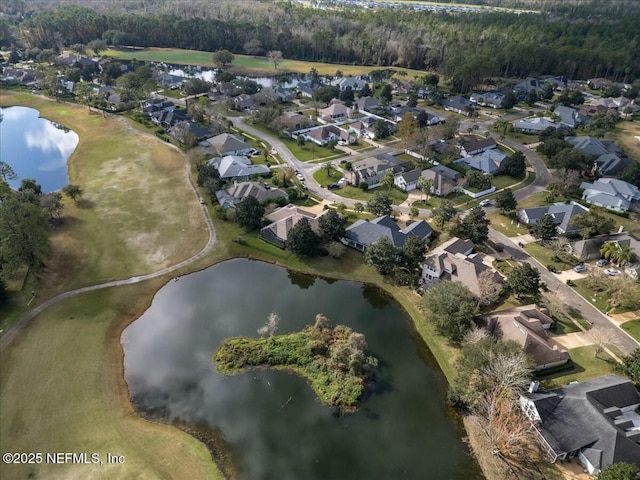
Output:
top-left (5, 0), bottom-right (640, 91)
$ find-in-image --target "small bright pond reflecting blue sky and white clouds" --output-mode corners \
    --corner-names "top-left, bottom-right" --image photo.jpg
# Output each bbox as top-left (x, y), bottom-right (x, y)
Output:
top-left (0, 107), bottom-right (78, 192)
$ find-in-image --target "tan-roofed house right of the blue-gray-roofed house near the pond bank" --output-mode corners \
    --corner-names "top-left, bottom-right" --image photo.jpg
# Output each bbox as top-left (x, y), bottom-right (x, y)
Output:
top-left (421, 237), bottom-right (502, 297)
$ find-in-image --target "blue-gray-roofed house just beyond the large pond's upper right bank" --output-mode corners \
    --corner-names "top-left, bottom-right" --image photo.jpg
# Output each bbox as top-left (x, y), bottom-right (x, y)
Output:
top-left (342, 215), bottom-right (433, 252)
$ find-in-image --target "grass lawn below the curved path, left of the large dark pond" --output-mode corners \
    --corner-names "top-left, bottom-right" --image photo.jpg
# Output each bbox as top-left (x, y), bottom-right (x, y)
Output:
top-left (0, 281), bottom-right (222, 479)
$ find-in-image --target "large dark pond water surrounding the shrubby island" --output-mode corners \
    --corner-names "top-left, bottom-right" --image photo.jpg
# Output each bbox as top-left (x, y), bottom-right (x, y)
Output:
top-left (122, 259), bottom-right (482, 480)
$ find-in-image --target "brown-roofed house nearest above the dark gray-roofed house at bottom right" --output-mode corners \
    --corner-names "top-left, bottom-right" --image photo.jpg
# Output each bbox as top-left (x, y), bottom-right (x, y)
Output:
top-left (476, 304), bottom-right (569, 371)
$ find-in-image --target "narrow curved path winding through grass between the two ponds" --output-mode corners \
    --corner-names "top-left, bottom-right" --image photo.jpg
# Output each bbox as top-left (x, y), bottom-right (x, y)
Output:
top-left (0, 139), bottom-right (216, 350)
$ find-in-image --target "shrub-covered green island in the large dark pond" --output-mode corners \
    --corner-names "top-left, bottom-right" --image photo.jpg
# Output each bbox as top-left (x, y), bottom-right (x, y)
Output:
top-left (213, 314), bottom-right (378, 412)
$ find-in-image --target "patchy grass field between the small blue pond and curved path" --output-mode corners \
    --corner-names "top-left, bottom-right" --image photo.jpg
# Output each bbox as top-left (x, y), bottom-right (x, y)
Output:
top-left (0, 91), bottom-right (207, 329)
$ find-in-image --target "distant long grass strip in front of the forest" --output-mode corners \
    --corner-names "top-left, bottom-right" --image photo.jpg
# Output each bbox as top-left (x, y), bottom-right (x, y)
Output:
top-left (104, 47), bottom-right (424, 77)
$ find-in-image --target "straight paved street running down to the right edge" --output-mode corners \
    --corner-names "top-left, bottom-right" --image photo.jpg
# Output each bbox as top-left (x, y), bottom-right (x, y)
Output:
top-left (489, 229), bottom-right (640, 354)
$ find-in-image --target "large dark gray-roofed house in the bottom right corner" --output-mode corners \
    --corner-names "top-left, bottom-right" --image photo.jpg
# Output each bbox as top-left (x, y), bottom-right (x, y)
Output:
top-left (520, 375), bottom-right (640, 475)
